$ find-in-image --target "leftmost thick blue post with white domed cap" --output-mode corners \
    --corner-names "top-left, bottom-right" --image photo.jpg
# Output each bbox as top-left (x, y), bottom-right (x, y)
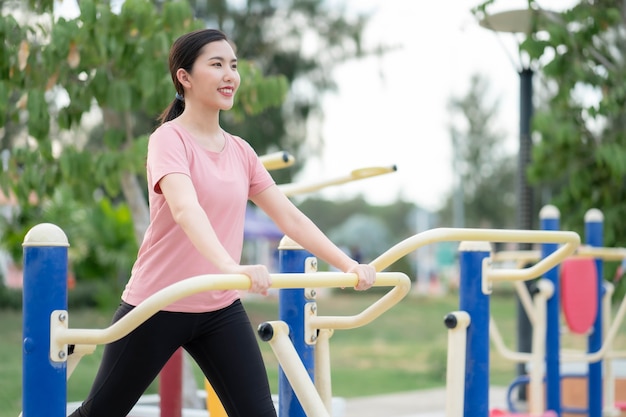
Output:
top-left (22, 223), bottom-right (69, 417)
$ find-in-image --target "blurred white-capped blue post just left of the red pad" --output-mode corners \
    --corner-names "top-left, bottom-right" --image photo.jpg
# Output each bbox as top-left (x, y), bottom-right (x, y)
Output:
top-left (539, 205), bottom-right (561, 416)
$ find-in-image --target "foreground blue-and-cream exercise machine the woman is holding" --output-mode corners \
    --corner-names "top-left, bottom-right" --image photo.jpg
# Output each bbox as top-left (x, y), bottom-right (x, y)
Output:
top-left (23, 219), bottom-right (579, 417)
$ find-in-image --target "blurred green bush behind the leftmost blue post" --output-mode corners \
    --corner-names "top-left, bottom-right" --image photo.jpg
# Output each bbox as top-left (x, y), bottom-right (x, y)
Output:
top-left (0, 187), bottom-right (138, 307)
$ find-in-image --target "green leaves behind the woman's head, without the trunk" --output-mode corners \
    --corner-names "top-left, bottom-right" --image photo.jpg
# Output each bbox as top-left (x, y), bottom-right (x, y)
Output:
top-left (0, 0), bottom-right (287, 197)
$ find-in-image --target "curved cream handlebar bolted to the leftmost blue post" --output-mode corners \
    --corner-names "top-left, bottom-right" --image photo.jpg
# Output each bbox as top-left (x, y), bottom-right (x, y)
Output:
top-left (50, 272), bottom-right (411, 345)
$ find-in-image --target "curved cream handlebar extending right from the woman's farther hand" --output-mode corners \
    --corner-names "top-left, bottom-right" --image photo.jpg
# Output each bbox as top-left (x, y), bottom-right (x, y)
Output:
top-left (371, 228), bottom-right (580, 281)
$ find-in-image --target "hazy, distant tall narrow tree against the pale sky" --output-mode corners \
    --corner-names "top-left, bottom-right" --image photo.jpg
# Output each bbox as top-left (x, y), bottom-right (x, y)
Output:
top-left (440, 75), bottom-right (516, 228)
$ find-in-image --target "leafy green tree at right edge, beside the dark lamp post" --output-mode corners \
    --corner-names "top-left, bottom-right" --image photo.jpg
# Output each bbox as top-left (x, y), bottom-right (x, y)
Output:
top-left (472, 0), bottom-right (626, 298)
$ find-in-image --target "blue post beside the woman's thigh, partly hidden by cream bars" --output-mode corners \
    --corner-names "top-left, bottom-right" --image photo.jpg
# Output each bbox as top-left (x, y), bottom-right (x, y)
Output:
top-left (278, 237), bottom-right (315, 417)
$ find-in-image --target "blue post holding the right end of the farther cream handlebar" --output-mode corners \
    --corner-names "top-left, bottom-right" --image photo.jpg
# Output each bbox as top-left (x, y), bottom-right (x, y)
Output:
top-left (459, 242), bottom-right (491, 417)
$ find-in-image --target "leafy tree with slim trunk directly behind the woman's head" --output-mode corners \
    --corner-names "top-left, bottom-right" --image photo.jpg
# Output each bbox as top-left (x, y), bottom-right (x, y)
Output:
top-left (0, 0), bottom-right (287, 249)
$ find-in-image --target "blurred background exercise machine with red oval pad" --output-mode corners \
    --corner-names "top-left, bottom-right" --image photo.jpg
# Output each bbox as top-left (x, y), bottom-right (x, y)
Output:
top-left (490, 206), bottom-right (626, 417)
